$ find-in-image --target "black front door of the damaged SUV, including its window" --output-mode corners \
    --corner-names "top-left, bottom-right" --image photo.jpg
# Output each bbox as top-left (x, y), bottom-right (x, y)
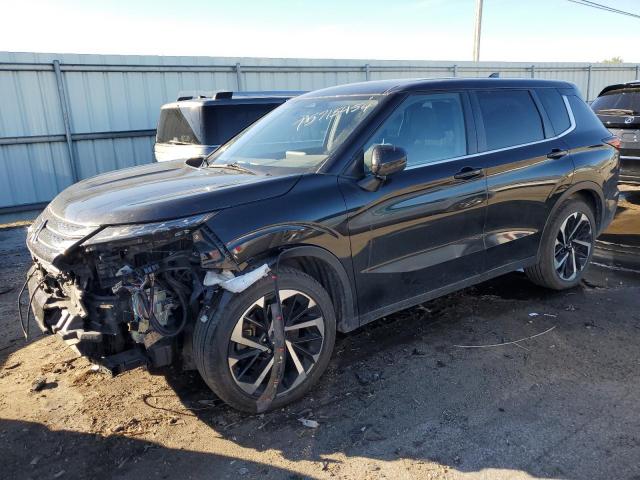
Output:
top-left (339, 92), bottom-right (487, 323)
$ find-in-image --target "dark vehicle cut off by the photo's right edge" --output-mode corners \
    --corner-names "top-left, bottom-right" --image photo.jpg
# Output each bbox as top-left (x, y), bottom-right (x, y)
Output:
top-left (591, 80), bottom-right (640, 183)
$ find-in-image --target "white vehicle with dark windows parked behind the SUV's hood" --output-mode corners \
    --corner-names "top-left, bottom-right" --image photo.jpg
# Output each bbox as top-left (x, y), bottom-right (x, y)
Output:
top-left (153, 91), bottom-right (304, 162)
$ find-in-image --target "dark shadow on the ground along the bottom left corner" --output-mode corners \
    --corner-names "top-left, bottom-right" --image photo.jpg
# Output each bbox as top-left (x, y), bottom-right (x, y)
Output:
top-left (0, 419), bottom-right (308, 480)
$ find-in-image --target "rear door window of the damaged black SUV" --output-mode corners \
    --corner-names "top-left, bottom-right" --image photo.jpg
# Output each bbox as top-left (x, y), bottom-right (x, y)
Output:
top-left (476, 90), bottom-right (544, 150)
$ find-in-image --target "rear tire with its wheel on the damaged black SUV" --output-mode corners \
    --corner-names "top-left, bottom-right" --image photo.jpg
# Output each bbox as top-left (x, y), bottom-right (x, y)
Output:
top-left (524, 198), bottom-right (596, 290)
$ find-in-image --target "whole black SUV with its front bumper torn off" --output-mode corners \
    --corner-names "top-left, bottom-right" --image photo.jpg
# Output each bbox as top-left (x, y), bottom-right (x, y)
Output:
top-left (27, 79), bottom-right (619, 411)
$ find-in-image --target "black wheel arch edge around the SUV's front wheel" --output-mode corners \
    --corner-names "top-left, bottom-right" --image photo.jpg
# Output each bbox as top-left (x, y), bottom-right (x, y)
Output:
top-left (226, 223), bottom-right (360, 332)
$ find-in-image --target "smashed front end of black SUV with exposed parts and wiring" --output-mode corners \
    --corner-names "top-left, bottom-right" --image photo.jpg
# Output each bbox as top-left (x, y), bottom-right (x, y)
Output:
top-left (27, 209), bottom-right (246, 374)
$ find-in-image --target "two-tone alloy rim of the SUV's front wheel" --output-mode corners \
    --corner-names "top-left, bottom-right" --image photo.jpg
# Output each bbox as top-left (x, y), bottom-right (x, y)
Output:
top-left (227, 290), bottom-right (325, 397)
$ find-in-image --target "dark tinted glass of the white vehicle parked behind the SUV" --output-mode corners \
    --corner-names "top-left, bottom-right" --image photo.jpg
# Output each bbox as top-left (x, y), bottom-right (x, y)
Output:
top-left (156, 103), bottom-right (280, 145)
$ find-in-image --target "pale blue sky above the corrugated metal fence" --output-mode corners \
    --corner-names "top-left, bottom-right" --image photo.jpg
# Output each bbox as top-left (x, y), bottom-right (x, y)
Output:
top-left (0, 0), bottom-right (640, 63)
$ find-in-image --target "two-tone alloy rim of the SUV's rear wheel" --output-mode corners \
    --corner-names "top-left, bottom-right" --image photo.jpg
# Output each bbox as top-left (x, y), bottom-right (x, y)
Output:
top-left (553, 212), bottom-right (593, 282)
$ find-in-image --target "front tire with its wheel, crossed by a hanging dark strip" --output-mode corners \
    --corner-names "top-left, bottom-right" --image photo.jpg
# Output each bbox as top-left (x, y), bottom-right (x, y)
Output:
top-left (193, 268), bottom-right (336, 413)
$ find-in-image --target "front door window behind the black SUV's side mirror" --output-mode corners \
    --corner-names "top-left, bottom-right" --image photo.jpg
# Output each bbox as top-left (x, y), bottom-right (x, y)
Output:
top-left (364, 93), bottom-right (467, 170)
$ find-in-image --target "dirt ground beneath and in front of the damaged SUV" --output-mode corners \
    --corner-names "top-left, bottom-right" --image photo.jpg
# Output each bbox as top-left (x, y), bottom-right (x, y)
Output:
top-left (0, 227), bottom-right (640, 480)
